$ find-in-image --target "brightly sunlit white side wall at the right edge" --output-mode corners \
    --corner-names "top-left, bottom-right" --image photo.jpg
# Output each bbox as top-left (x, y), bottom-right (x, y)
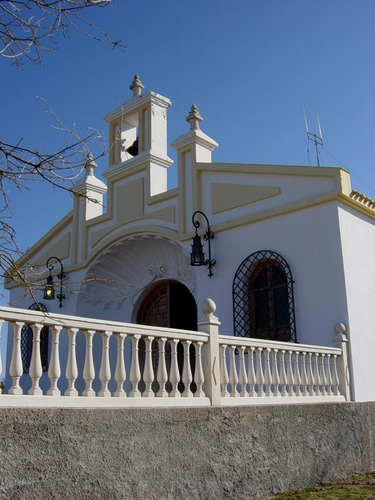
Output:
top-left (339, 206), bottom-right (375, 401)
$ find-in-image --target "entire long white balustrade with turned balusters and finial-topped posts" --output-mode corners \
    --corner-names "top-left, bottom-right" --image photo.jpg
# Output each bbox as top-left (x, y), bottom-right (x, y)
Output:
top-left (0, 300), bottom-right (350, 407)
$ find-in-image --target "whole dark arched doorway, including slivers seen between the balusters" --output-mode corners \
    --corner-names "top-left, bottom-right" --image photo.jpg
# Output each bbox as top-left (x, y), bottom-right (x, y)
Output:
top-left (137, 281), bottom-right (198, 393)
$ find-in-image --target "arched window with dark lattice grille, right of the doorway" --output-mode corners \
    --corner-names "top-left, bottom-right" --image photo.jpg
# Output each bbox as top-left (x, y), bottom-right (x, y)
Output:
top-left (233, 250), bottom-right (297, 342)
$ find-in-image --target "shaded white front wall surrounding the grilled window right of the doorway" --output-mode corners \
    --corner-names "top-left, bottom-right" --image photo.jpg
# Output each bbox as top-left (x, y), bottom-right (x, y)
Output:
top-left (196, 203), bottom-right (347, 346)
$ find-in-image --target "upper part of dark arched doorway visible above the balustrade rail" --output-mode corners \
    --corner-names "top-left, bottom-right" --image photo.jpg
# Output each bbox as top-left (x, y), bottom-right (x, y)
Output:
top-left (137, 281), bottom-right (197, 330)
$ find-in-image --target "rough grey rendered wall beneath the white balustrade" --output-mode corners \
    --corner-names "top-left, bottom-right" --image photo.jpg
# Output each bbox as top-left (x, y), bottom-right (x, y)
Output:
top-left (0, 403), bottom-right (375, 500)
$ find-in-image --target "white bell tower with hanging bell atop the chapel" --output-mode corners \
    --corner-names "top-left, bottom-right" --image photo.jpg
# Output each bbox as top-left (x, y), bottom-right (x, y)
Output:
top-left (104, 75), bottom-right (173, 196)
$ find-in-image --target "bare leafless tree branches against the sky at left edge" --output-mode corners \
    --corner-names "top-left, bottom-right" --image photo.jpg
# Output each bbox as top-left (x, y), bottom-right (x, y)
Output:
top-left (0, 0), bottom-right (124, 297)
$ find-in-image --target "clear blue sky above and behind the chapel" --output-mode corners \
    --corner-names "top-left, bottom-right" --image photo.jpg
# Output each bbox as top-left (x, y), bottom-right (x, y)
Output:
top-left (0, 0), bottom-right (375, 280)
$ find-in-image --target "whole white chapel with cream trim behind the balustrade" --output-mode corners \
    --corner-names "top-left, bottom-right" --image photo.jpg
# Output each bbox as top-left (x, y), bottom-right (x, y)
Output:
top-left (7, 76), bottom-right (375, 401)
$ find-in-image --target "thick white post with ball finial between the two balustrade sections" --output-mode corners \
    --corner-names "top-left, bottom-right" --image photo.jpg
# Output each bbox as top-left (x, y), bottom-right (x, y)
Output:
top-left (198, 299), bottom-right (221, 406)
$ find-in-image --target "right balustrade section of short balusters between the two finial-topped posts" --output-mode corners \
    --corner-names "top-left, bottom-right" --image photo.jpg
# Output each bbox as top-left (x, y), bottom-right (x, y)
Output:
top-left (220, 335), bottom-right (350, 405)
